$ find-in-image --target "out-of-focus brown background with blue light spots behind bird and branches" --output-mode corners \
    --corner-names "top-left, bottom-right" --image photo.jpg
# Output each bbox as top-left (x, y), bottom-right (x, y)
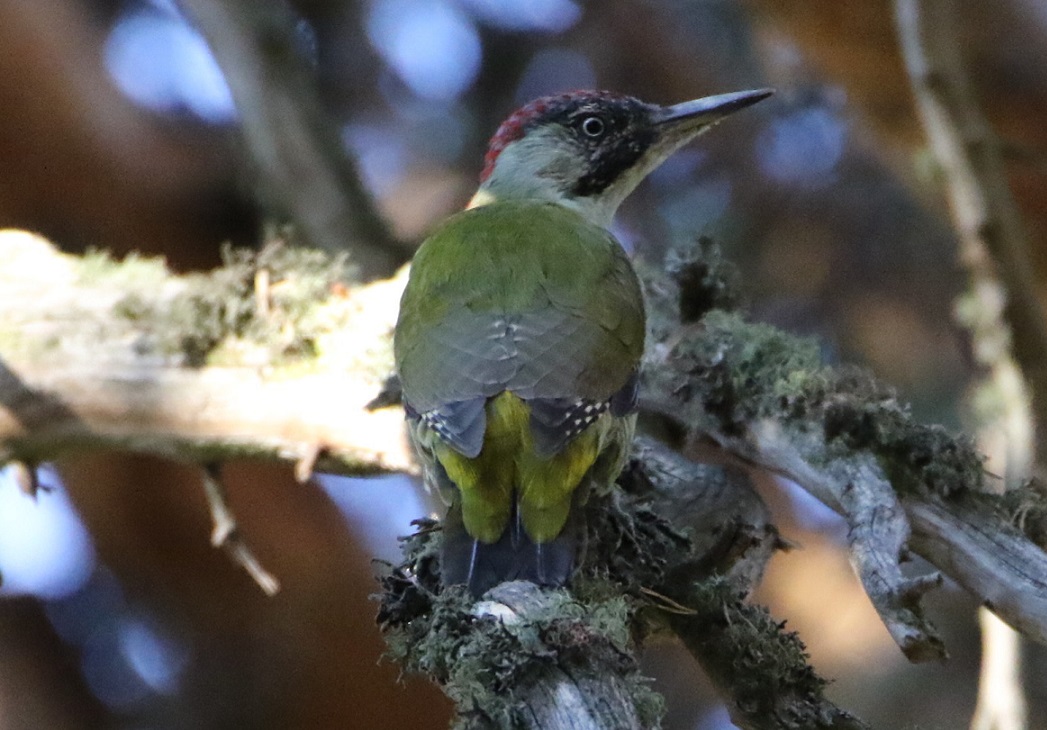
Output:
top-left (0, 0), bottom-right (1047, 730)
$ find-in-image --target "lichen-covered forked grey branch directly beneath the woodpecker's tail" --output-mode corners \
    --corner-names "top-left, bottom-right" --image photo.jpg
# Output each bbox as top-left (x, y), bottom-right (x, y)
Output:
top-left (379, 440), bottom-right (865, 730)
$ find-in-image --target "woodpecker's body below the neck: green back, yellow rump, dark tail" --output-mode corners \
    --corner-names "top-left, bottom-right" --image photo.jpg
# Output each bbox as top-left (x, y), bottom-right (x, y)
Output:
top-left (395, 201), bottom-right (645, 573)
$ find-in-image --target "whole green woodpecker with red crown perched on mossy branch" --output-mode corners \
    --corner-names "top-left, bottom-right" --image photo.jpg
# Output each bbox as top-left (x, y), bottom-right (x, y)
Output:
top-left (395, 89), bottom-right (771, 596)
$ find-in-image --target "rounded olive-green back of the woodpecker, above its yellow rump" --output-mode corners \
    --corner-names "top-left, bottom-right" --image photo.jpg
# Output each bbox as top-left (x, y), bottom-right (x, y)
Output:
top-left (395, 201), bottom-right (645, 413)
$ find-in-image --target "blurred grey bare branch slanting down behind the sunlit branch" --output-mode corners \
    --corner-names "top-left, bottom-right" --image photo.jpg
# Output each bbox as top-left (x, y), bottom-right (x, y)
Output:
top-left (182, 0), bottom-right (410, 281)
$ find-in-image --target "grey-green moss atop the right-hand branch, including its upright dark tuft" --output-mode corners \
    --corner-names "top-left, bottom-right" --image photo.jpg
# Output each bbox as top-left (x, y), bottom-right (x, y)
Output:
top-left (645, 241), bottom-right (984, 495)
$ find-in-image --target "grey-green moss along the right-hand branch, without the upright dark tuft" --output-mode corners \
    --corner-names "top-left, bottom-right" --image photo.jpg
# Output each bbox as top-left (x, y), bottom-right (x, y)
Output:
top-left (670, 310), bottom-right (983, 495)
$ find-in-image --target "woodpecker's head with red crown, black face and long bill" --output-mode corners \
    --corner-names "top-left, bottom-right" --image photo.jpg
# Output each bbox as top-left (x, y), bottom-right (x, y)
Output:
top-left (469, 89), bottom-right (773, 227)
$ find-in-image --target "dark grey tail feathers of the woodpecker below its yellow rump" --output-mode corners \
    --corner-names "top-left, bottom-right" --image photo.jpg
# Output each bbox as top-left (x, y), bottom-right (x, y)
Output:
top-left (441, 505), bottom-right (584, 598)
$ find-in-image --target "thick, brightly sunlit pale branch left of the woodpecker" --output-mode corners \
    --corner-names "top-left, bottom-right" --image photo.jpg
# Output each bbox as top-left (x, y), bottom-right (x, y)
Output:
top-left (0, 230), bottom-right (415, 474)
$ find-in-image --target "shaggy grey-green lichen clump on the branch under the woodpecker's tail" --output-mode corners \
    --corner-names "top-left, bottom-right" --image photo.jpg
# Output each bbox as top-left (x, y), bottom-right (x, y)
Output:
top-left (378, 522), bottom-right (662, 728)
